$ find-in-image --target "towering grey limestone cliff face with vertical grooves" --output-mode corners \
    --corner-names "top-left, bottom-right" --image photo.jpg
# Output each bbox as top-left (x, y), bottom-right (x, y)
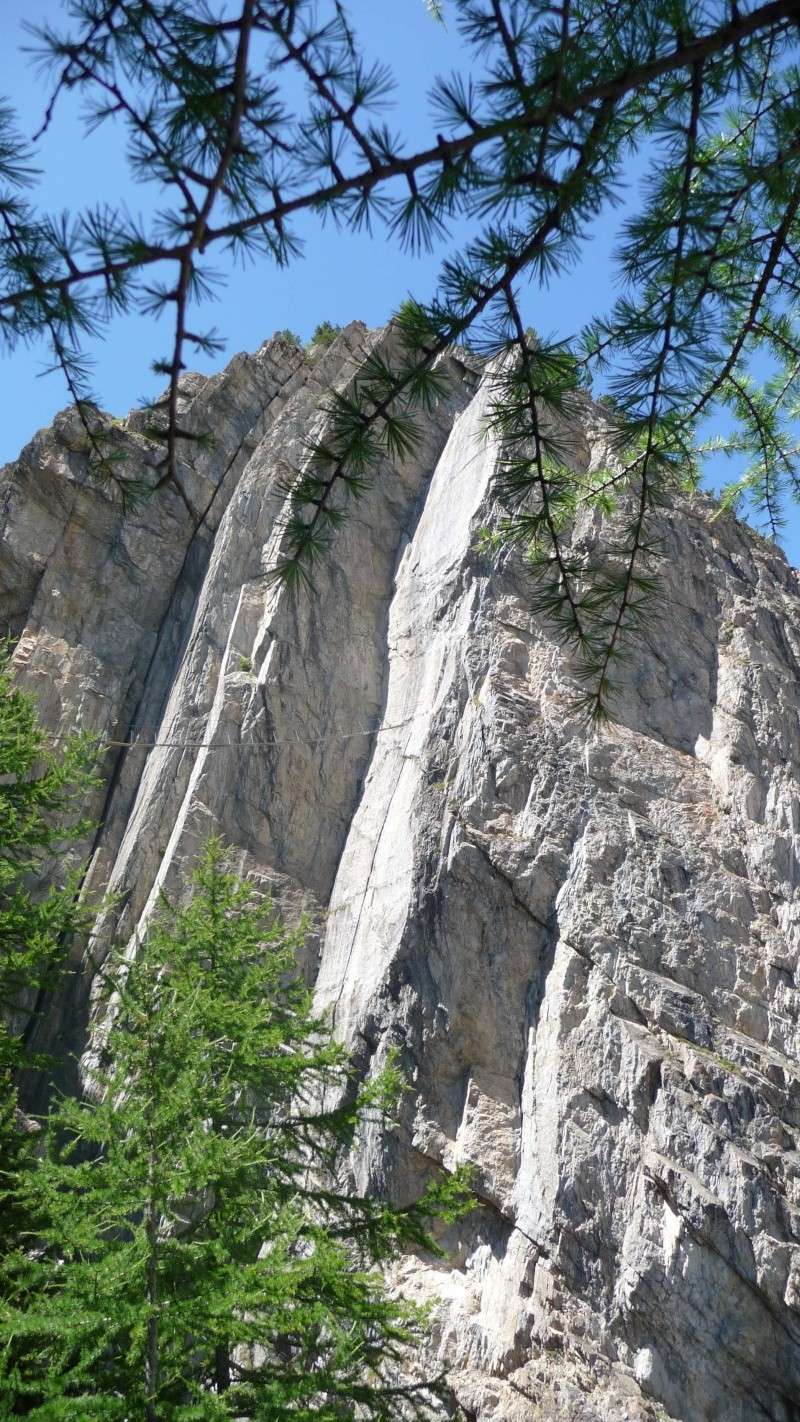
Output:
top-left (0, 324), bottom-right (800, 1422)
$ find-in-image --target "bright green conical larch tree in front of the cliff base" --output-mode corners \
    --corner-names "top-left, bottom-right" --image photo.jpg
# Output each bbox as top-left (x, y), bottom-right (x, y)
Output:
top-left (0, 842), bottom-right (466, 1422)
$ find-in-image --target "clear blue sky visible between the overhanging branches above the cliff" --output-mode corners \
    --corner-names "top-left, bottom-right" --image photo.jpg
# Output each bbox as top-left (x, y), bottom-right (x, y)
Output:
top-left (0, 0), bottom-right (800, 563)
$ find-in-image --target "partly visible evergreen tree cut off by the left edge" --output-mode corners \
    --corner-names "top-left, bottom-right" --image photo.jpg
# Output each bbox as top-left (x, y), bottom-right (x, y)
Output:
top-left (0, 643), bottom-right (94, 1251)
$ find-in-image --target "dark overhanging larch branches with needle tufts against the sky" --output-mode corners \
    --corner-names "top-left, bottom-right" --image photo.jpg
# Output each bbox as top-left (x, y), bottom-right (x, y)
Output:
top-left (0, 0), bottom-right (800, 720)
